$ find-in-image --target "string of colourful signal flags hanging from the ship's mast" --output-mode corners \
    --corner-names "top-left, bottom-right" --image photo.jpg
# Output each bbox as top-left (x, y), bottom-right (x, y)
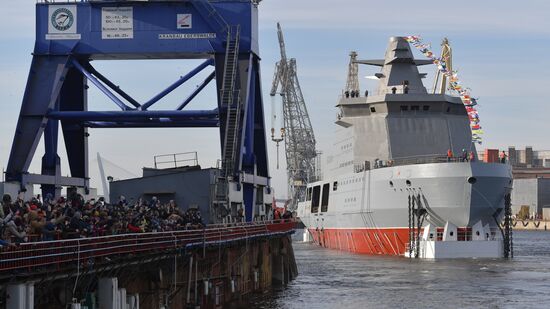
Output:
top-left (405, 35), bottom-right (483, 145)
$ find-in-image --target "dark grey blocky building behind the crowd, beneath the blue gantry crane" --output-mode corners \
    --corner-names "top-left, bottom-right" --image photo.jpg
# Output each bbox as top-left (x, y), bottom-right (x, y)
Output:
top-left (109, 169), bottom-right (216, 223)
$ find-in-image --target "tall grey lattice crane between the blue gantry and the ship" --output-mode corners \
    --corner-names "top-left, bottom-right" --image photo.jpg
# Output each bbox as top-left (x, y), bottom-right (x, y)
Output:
top-left (270, 23), bottom-right (317, 211)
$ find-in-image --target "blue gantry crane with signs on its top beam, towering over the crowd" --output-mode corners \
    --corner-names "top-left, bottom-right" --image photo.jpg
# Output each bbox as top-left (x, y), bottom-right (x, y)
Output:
top-left (6, 0), bottom-right (271, 221)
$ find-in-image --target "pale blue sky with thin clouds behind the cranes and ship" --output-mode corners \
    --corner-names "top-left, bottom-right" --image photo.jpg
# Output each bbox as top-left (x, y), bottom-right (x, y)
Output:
top-left (0, 0), bottom-right (550, 195)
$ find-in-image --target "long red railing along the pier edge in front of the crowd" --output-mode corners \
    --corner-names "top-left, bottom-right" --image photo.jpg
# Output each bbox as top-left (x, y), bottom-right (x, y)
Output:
top-left (0, 219), bottom-right (296, 275)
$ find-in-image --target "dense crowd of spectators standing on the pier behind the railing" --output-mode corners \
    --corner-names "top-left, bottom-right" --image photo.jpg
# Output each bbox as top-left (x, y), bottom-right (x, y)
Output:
top-left (0, 194), bottom-right (204, 247)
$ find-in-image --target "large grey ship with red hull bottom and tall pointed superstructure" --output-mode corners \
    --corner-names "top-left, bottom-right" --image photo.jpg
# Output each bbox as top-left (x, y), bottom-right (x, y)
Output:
top-left (297, 37), bottom-right (512, 258)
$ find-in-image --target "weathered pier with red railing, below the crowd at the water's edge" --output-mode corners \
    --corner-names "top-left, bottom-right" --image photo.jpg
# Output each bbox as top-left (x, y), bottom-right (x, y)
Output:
top-left (0, 220), bottom-right (297, 309)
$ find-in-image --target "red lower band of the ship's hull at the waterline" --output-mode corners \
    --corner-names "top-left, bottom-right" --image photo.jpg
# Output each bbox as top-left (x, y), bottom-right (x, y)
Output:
top-left (309, 228), bottom-right (409, 255)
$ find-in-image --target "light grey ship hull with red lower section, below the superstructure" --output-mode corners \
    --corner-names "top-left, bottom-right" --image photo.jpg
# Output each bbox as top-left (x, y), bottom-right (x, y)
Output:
top-left (298, 162), bottom-right (511, 257)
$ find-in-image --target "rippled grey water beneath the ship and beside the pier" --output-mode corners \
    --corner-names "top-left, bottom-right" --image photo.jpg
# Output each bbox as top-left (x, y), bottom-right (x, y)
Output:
top-left (251, 231), bottom-right (550, 309)
